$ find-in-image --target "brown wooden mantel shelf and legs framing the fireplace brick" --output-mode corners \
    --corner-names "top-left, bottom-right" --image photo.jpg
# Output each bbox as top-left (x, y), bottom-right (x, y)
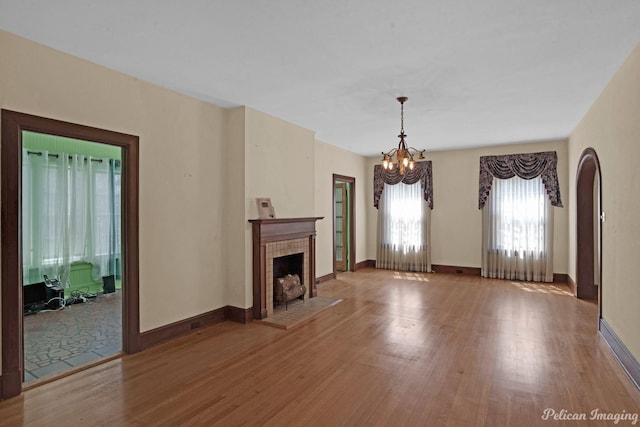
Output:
top-left (249, 217), bottom-right (324, 319)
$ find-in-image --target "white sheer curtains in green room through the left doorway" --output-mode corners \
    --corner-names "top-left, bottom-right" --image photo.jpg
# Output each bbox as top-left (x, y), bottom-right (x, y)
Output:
top-left (22, 150), bottom-right (120, 287)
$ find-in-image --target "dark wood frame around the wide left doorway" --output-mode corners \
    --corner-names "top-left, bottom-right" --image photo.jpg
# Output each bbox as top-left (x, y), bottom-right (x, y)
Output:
top-left (0, 109), bottom-right (140, 399)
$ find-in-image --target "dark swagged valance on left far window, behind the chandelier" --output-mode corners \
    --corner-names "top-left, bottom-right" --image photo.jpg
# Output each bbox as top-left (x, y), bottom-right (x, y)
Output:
top-left (373, 160), bottom-right (433, 209)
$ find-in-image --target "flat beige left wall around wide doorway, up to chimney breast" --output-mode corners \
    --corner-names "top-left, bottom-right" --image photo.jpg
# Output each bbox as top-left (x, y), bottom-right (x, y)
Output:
top-left (0, 31), bottom-right (229, 331)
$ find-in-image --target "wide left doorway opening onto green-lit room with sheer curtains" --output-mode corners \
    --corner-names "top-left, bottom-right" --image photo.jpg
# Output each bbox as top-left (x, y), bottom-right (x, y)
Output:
top-left (21, 131), bottom-right (123, 385)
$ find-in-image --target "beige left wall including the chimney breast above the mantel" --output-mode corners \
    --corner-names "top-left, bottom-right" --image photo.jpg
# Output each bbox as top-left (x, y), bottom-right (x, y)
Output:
top-left (0, 31), bottom-right (340, 342)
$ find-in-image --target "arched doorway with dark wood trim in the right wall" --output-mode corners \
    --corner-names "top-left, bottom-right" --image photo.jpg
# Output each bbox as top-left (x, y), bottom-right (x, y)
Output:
top-left (576, 148), bottom-right (602, 310)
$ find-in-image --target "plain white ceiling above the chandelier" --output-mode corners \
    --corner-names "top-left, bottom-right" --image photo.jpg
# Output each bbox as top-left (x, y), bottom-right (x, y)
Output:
top-left (0, 0), bottom-right (640, 155)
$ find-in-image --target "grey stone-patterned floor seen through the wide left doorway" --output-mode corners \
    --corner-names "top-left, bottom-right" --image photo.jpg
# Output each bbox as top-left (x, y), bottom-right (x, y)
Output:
top-left (24, 290), bottom-right (122, 383)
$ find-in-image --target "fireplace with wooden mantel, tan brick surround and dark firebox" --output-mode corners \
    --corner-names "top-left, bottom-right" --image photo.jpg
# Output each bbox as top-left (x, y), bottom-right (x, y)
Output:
top-left (249, 217), bottom-right (322, 319)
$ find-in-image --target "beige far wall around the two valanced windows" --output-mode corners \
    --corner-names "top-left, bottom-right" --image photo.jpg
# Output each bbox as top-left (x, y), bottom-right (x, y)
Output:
top-left (367, 141), bottom-right (569, 273)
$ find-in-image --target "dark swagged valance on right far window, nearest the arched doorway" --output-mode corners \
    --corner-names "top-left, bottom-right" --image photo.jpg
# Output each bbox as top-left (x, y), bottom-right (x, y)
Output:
top-left (478, 151), bottom-right (562, 209)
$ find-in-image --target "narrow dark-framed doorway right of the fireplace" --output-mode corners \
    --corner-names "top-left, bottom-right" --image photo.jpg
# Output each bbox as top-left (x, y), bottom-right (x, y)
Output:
top-left (333, 174), bottom-right (356, 274)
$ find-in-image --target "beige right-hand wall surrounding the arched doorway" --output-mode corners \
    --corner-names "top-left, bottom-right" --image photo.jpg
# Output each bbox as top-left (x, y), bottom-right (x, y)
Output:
top-left (569, 45), bottom-right (640, 360)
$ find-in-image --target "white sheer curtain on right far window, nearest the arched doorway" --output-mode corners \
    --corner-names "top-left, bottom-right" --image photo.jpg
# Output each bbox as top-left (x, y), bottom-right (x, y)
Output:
top-left (482, 176), bottom-right (553, 282)
